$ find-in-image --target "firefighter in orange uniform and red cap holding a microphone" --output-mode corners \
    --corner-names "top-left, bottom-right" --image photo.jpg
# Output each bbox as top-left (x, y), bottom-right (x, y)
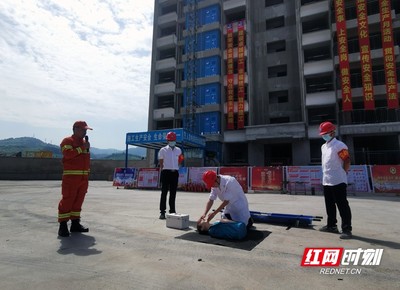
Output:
top-left (58, 121), bottom-right (92, 237)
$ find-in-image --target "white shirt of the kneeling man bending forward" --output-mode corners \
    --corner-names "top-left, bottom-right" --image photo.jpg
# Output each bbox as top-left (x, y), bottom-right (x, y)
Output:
top-left (210, 175), bottom-right (250, 225)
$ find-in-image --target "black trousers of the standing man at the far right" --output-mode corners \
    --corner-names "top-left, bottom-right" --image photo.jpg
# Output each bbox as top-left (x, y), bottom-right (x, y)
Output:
top-left (324, 183), bottom-right (352, 231)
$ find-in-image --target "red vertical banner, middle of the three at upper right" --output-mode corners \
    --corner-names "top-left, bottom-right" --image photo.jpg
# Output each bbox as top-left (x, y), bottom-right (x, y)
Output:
top-left (357, 0), bottom-right (375, 110)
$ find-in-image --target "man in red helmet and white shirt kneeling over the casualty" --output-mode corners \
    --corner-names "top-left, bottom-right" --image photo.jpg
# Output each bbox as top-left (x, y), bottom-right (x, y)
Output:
top-left (198, 170), bottom-right (253, 228)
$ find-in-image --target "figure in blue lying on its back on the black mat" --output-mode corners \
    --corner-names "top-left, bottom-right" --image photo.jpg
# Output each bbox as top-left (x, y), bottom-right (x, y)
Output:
top-left (197, 219), bottom-right (247, 240)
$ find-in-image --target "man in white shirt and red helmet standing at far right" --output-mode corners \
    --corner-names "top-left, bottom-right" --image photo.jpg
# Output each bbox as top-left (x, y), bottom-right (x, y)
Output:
top-left (319, 122), bottom-right (352, 239)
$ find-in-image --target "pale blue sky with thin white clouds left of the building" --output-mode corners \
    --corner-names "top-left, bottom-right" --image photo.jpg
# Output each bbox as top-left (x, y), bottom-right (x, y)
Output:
top-left (0, 0), bottom-right (154, 149)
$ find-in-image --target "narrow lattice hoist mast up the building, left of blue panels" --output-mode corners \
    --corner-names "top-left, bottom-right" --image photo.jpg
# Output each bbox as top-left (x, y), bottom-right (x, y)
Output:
top-left (184, 0), bottom-right (198, 133)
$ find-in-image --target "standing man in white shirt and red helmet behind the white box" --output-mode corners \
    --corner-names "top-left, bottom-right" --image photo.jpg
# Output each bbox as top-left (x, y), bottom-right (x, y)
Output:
top-left (158, 132), bottom-right (183, 220)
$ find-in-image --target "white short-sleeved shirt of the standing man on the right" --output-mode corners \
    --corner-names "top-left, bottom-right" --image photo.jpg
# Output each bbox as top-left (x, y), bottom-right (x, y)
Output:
top-left (321, 138), bottom-right (348, 186)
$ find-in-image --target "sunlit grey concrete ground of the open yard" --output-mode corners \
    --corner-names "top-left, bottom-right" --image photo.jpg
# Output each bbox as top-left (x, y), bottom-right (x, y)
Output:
top-left (0, 181), bottom-right (400, 290)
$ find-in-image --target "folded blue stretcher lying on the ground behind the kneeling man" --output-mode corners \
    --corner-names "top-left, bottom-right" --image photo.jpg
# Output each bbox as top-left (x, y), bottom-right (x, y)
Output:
top-left (250, 211), bottom-right (322, 227)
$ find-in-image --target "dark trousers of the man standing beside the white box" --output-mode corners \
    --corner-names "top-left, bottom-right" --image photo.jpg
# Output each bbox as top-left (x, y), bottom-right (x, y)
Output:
top-left (160, 170), bottom-right (179, 213)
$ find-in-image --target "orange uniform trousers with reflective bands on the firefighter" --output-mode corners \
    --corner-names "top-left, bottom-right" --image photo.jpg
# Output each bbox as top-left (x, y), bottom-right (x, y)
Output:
top-left (58, 175), bottom-right (89, 222)
